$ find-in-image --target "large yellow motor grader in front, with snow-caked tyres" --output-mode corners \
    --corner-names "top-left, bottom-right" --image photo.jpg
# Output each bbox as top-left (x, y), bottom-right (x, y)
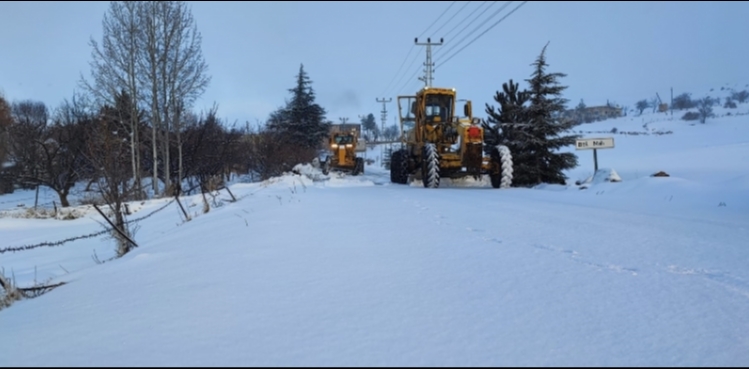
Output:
top-left (390, 87), bottom-right (512, 188)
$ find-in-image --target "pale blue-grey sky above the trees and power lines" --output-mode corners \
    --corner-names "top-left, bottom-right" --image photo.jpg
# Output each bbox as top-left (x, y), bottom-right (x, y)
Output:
top-left (0, 1), bottom-right (749, 124)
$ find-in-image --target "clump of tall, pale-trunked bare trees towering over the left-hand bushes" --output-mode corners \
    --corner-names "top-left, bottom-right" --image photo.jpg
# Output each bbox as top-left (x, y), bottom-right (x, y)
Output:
top-left (83, 1), bottom-right (210, 198)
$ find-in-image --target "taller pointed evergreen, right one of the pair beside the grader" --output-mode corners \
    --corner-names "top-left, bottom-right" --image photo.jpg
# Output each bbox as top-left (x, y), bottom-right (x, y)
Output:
top-left (524, 43), bottom-right (580, 184)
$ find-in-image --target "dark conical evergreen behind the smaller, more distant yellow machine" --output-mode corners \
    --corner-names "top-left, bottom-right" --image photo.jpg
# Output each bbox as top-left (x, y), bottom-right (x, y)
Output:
top-left (268, 64), bottom-right (330, 148)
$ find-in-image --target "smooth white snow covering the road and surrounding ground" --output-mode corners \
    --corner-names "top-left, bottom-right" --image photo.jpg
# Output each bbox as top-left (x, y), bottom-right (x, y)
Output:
top-left (0, 87), bottom-right (749, 366)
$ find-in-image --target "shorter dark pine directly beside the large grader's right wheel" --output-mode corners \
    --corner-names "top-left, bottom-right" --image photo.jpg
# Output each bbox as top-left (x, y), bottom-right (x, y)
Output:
top-left (482, 79), bottom-right (535, 186)
